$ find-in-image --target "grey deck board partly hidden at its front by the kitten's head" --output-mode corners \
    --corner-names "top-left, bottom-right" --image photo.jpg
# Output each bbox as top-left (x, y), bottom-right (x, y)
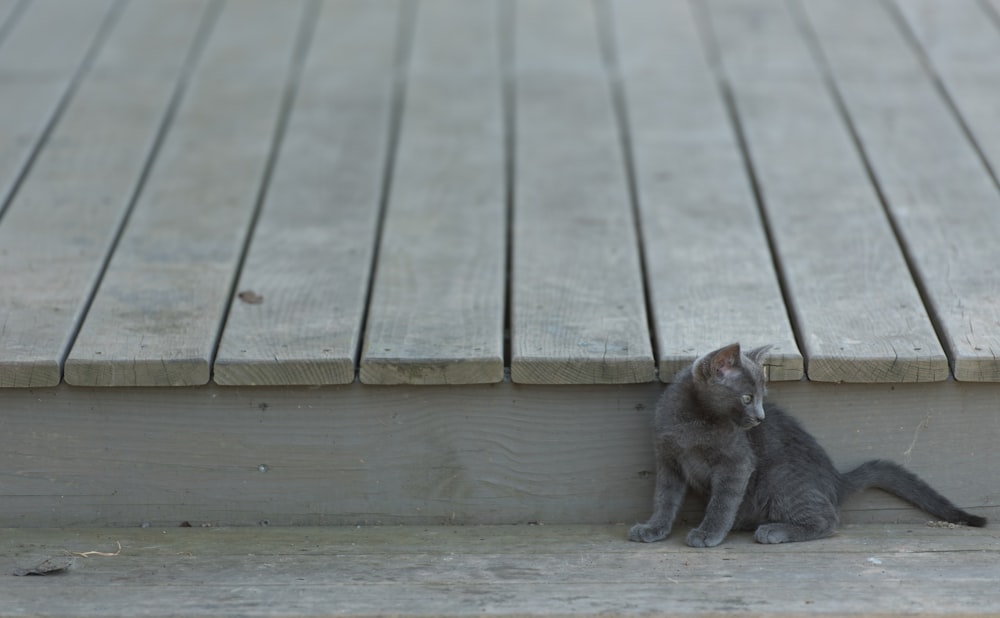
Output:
top-left (614, 0), bottom-right (803, 381)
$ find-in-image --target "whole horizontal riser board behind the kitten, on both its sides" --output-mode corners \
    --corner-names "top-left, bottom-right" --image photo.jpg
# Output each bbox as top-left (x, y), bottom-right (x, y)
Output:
top-left (0, 381), bottom-right (1000, 526)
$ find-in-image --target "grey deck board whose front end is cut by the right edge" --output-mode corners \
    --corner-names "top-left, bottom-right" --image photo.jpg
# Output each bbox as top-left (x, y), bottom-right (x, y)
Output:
top-left (805, 0), bottom-right (1000, 381)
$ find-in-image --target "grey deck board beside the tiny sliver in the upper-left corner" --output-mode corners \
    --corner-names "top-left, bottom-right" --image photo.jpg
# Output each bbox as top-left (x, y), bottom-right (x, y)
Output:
top-left (0, 0), bottom-right (112, 215)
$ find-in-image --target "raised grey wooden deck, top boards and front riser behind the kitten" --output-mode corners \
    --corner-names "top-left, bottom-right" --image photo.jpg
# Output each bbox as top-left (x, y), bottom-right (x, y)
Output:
top-left (0, 0), bottom-right (1000, 526)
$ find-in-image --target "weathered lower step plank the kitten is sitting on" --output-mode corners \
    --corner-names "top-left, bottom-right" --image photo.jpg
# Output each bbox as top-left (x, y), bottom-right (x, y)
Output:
top-left (0, 526), bottom-right (1000, 616)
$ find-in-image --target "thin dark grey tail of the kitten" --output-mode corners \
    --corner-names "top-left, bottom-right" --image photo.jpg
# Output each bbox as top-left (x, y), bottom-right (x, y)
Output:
top-left (841, 459), bottom-right (986, 528)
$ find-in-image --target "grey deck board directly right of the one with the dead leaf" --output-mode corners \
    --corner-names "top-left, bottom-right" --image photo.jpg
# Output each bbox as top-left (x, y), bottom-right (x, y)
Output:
top-left (360, 0), bottom-right (507, 384)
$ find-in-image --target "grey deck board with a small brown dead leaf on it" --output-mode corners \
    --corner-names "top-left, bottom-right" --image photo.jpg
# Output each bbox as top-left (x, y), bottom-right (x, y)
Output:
top-left (214, 0), bottom-right (399, 385)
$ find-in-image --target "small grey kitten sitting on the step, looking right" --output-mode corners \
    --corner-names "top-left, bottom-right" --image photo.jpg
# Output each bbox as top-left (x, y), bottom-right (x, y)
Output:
top-left (629, 343), bottom-right (986, 547)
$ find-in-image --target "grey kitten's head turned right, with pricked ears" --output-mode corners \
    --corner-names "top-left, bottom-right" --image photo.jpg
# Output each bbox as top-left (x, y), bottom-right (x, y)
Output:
top-left (692, 343), bottom-right (771, 429)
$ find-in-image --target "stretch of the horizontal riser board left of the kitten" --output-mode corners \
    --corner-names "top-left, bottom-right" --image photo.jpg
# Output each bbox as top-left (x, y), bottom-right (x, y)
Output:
top-left (0, 382), bottom-right (659, 526)
